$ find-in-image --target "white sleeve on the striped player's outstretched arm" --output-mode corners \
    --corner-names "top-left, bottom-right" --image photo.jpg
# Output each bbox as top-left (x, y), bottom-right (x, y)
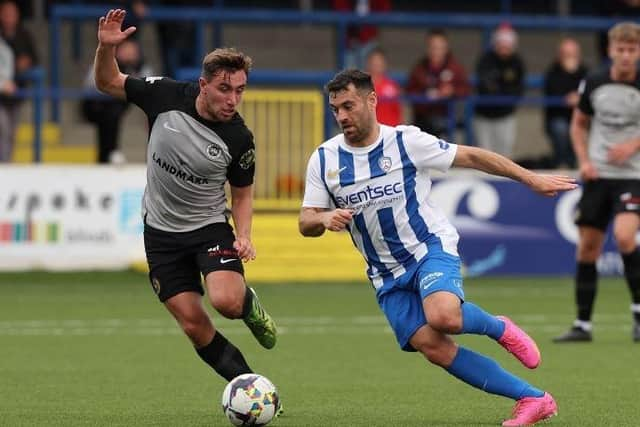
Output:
top-left (398, 126), bottom-right (458, 172)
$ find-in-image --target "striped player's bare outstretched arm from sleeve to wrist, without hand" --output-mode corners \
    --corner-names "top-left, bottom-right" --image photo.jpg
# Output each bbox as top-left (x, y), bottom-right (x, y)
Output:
top-left (453, 145), bottom-right (533, 183)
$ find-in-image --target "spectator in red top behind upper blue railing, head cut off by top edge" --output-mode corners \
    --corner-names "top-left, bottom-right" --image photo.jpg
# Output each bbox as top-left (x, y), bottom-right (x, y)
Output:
top-left (332, 0), bottom-right (391, 68)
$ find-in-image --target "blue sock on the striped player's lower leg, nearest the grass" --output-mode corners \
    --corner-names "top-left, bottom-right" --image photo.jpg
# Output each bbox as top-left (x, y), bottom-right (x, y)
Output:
top-left (445, 348), bottom-right (544, 400)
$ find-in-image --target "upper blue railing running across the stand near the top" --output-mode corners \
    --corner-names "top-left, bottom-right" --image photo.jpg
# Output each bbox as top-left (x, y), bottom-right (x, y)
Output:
top-left (49, 3), bottom-right (632, 121)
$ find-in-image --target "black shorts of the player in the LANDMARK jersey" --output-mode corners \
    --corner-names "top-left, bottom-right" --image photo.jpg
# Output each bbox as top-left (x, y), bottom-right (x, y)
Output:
top-left (144, 223), bottom-right (244, 302)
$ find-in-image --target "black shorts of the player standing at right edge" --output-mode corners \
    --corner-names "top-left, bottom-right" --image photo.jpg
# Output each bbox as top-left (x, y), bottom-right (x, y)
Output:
top-left (575, 178), bottom-right (640, 231)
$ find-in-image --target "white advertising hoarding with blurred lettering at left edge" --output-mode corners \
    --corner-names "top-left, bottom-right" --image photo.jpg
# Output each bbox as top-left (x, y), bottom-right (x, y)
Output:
top-left (0, 165), bottom-right (146, 270)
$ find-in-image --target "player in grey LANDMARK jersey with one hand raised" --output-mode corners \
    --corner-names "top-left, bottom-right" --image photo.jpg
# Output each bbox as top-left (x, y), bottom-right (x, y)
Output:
top-left (94, 9), bottom-right (276, 400)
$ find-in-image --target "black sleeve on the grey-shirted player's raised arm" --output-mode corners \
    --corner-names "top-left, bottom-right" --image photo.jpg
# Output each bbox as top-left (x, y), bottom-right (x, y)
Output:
top-left (124, 76), bottom-right (183, 117)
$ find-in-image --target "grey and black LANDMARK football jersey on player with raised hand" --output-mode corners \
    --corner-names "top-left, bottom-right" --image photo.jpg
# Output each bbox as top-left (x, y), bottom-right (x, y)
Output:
top-left (125, 76), bottom-right (255, 232)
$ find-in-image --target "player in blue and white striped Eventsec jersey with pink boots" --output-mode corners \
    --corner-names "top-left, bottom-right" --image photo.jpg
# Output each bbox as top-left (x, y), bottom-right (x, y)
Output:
top-left (299, 70), bottom-right (576, 426)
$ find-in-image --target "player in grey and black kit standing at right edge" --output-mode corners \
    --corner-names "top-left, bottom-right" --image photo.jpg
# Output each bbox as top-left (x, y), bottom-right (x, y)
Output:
top-left (554, 22), bottom-right (640, 342)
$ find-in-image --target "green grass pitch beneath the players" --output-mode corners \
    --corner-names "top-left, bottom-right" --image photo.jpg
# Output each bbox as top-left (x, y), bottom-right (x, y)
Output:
top-left (0, 272), bottom-right (640, 427)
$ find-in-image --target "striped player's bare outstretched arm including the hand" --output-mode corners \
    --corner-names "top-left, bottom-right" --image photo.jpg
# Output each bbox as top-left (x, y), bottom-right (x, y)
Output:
top-left (453, 145), bottom-right (577, 196)
